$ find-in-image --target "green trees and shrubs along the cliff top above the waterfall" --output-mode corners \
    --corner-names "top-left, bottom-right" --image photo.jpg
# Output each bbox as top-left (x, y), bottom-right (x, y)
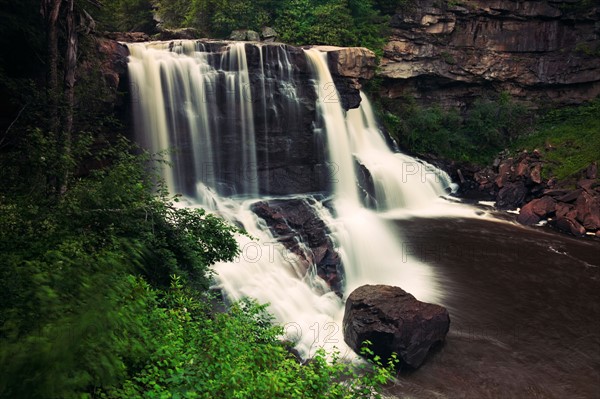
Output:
top-left (96, 0), bottom-right (394, 53)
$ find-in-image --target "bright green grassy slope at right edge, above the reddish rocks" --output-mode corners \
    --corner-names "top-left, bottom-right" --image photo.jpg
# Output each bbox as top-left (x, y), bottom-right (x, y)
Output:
top-left (511, 98), bottom-right (600, 179)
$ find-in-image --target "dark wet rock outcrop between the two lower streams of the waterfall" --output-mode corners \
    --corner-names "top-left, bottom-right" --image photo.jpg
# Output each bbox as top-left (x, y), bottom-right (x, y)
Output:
top-left (251, 199), bottom-right (343, 296)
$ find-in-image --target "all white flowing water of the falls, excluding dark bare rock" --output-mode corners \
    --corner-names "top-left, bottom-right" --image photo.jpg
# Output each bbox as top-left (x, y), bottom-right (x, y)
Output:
top-left (129, 42), bottom-right (462, 356)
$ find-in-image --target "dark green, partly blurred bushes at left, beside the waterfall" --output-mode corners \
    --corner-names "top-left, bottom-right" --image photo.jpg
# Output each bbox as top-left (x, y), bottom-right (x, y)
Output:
top-left (0, 134), bottom-right (237, 398)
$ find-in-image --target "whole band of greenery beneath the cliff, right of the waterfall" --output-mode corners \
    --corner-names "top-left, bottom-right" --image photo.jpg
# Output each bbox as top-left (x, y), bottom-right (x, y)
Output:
top-left (369, 88), bottom-right (600, 180)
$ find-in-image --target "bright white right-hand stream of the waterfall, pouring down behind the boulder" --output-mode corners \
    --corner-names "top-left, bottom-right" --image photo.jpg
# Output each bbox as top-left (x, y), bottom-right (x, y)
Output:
top-left (306, 50), bottom-right (443, 302)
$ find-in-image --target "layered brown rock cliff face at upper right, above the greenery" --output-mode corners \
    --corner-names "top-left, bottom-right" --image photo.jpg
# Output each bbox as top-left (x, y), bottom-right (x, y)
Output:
top-left (379, 0), bottom-right (600, 107)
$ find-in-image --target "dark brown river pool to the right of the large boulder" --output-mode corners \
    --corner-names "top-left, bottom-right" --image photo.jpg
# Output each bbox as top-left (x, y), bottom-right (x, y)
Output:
top-left (386, 218), bottom-right (600, 399)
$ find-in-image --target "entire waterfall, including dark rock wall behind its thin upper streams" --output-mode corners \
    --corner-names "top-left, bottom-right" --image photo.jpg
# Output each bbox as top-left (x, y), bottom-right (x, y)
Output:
top-left (129, 41), bottom-right (450, 356)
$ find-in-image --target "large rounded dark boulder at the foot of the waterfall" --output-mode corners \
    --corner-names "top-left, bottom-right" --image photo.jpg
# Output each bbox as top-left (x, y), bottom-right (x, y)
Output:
top-left (343, 285), bottom-right (450, 368)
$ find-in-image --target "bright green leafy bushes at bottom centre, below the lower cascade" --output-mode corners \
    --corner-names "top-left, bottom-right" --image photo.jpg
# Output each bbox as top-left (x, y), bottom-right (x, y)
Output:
top-left (100, 290), bottom-right (396, 399)
